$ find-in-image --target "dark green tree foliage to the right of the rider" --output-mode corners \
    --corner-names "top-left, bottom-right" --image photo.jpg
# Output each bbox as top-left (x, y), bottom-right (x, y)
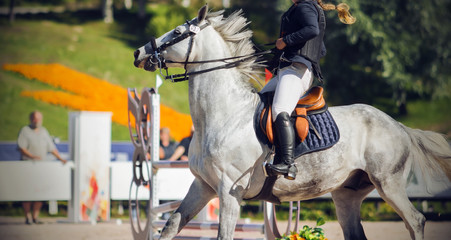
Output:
top-left (325, 0), bottom-right (451, 114)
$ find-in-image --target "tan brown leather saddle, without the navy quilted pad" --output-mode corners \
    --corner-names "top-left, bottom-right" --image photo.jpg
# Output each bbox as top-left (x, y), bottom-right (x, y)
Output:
top-left (259, 86), bottom-right (327, 144)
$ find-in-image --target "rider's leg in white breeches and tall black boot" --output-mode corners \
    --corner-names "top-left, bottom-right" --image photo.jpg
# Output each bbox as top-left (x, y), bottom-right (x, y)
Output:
top-left (270, 63), bottom-right (313, 179)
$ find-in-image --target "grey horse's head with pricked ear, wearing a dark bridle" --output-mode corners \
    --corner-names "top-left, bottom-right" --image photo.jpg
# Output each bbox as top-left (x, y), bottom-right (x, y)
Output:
top-left (133, 5), bottom-right (208, 72)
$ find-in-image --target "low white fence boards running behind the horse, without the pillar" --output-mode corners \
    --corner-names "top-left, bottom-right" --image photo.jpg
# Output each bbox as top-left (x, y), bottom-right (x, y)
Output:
top-left (0, 161), bottom-right (451, 201)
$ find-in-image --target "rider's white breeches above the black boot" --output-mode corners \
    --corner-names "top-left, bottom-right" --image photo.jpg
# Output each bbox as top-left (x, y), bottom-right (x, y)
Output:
top-left (261, 63), bottom-right (313, 121)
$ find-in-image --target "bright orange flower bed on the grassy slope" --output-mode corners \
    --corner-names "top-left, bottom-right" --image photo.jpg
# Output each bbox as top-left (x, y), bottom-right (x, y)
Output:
top-left (3, 63), bottom-right (192, 141)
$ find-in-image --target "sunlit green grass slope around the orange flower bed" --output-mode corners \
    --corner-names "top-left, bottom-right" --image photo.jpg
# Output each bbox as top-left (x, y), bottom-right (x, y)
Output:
top-left (0, 20), bottom-right (189, 141)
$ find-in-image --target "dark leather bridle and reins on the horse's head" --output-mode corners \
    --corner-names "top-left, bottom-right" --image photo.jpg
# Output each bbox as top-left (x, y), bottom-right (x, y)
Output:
top-left (145, 20), bottom-right (271, 82)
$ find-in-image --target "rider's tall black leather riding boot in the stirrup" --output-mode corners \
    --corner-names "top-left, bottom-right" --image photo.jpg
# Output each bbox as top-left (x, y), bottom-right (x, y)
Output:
top-left (269, 112), bottom-right (297, 180)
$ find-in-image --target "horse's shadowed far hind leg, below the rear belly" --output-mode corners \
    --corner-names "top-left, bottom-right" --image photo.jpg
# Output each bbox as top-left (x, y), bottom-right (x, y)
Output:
top-left (332, 185), bottom-right (374, 240)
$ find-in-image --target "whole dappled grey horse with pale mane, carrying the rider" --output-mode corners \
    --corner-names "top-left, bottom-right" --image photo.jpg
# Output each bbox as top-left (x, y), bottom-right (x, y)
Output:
top-left (134, 6), bottom-right (451, 239)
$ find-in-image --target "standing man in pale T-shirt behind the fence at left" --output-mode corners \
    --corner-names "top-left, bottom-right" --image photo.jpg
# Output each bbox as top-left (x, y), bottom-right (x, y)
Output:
top-left (17, 111), bottom-right (67, 224)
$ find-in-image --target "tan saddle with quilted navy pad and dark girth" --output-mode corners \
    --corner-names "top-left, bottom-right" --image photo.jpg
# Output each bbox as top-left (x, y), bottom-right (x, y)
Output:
top-left (249, 87), bottom-right (340, 204)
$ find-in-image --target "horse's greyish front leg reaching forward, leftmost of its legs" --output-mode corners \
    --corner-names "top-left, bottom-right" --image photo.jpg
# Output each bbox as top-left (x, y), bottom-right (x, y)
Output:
top-left (160, 178), bottom-right (216, 239)
